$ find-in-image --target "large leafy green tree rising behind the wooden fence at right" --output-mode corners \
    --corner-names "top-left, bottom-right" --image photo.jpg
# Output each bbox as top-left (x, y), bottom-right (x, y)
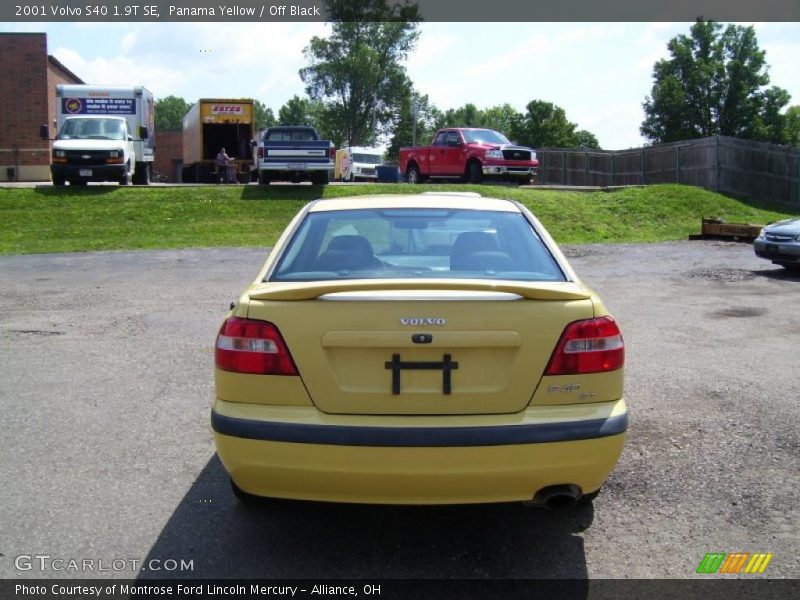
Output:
top-left (641, 19), bottom-right (790, 142)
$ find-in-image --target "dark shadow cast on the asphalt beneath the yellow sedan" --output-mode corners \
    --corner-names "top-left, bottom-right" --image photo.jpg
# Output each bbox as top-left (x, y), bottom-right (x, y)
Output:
top-left (140, 455), bottom-right (594, 579)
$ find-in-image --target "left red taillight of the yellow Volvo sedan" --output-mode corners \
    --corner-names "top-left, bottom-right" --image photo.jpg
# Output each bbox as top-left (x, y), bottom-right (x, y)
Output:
top-left (214, 317), bottom-right (297, 375)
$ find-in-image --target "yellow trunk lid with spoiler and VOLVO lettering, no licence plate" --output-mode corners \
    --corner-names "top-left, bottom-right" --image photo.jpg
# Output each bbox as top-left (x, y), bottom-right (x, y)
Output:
top-left (247, 280), bottom-right (593, 415)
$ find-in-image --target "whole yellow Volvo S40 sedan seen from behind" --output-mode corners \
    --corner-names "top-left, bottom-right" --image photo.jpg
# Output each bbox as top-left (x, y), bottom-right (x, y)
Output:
top-left (212, 194), bottom-right (628, 506)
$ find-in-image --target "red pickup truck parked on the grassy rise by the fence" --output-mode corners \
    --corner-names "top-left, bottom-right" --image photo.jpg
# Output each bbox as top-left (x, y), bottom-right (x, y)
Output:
top-left (400, 127), bottom-right (539, 183)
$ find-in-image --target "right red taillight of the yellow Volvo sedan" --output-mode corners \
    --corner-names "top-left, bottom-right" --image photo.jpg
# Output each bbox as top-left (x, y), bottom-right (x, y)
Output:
top-left (544, 317), bottom-right (625, 375)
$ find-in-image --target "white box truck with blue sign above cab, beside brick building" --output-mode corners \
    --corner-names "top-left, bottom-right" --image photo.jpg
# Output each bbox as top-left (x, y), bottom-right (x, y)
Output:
top-left (40, 85), bottom-right (154, 185)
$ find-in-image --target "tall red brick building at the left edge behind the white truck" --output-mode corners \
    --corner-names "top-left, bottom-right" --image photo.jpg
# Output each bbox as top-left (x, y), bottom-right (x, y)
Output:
top-left (0, 33), bottom-right (84, 181)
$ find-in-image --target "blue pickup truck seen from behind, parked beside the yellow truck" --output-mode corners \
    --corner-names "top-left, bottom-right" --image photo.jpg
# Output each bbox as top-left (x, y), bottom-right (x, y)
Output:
top-left (253, 126), bottom-right (336, 185)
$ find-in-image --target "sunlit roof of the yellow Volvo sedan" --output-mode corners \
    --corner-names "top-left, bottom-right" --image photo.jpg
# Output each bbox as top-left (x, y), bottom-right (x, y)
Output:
top-left (309, 192), bottom-right (520, 213)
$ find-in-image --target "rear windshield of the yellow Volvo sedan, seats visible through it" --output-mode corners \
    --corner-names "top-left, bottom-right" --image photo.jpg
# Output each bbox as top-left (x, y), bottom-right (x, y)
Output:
top-left (270, 208), bottom-right (565, 281)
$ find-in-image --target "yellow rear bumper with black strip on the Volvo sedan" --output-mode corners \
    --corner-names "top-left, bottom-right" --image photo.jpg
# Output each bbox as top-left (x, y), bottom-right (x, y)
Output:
top-left (212, 400), bottom-right (628, 504)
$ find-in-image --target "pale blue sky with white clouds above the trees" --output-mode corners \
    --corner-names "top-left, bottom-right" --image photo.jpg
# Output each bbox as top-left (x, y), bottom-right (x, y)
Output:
top-left (0, 23), bottom-right (800, 150)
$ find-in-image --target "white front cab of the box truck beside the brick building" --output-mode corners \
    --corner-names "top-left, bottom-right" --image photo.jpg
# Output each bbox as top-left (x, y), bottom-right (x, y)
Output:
top-left (50, 115), bottom-right (136, 185)
